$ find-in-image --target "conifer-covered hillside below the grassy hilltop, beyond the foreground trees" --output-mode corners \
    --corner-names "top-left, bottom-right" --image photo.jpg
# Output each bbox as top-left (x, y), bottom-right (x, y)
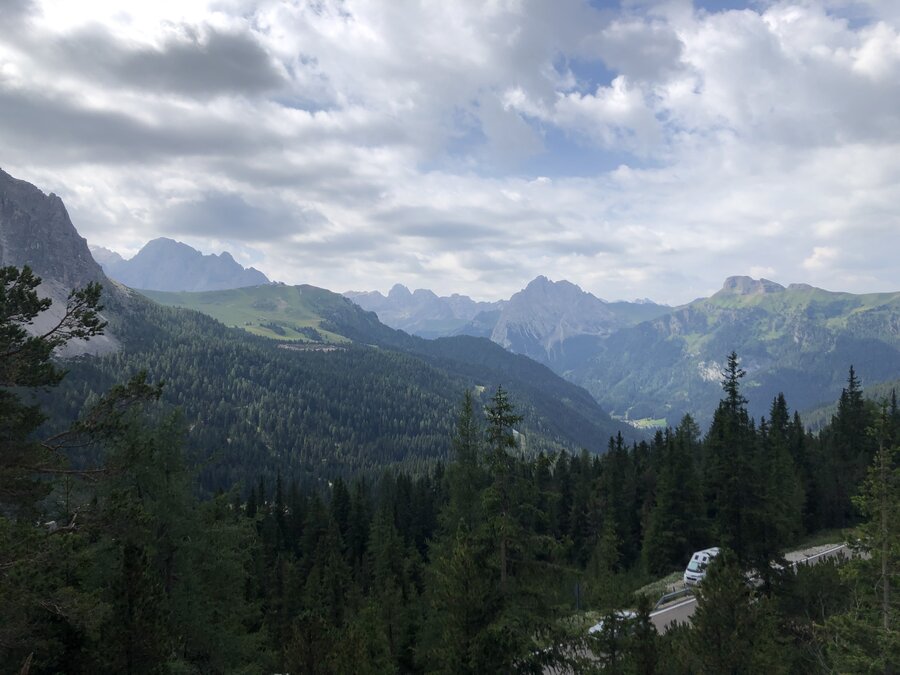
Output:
top-left (42, 287), bottom-right (632, 490)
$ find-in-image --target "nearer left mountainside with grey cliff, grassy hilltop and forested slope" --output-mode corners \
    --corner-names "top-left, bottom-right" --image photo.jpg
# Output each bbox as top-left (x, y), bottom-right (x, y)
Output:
top-left (0, 167), bottom-right (638, 490)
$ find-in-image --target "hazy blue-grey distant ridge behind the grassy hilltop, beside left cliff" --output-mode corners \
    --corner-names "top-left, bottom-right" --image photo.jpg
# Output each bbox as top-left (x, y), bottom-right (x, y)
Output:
top-left (93, 237), bottom-right (269, 291)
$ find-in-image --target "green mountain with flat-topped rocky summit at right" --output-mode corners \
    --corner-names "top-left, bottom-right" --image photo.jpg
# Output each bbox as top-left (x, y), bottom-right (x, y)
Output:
top-left (567, 280), bottom-right (900, 423)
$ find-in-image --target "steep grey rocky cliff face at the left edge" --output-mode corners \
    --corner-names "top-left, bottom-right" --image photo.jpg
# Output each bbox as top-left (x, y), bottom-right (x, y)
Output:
top-left (0, 170), bottom-right (125, 356)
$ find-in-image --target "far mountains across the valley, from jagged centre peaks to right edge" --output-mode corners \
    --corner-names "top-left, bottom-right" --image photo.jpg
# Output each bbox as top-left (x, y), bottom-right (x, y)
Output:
top-left (348, 276), bottom-right (900, 427)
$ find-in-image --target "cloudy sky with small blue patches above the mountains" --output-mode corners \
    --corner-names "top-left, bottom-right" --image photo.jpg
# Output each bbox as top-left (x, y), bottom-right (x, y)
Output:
top-left (0, 0), bottom-right (900, 304)
